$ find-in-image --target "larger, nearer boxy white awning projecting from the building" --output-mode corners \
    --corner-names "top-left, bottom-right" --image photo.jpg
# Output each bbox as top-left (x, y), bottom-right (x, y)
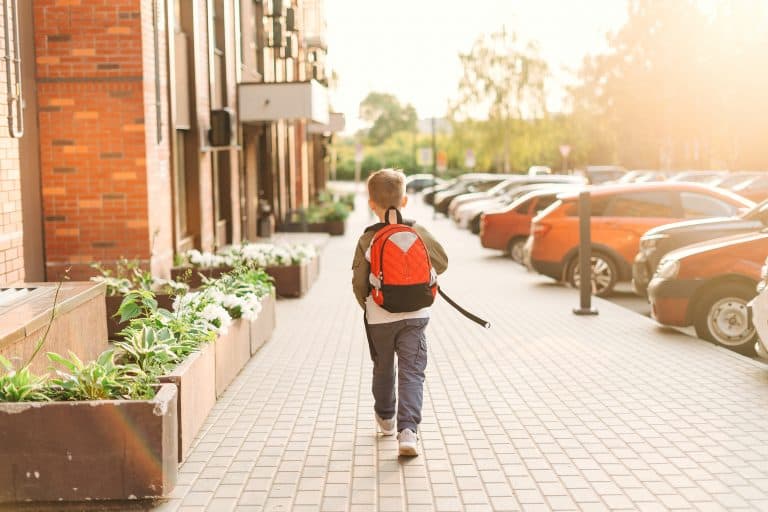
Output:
top-left (238, 80), bottom-right (330, 125)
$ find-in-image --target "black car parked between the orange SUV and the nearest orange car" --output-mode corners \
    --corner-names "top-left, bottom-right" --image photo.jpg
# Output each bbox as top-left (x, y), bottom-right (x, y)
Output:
top-left (632, 200), bottom-right (768, 297)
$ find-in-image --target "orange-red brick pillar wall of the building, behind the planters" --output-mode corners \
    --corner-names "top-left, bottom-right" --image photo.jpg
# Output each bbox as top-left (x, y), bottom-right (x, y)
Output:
top-left (35, 0), bottom-right (171, 280)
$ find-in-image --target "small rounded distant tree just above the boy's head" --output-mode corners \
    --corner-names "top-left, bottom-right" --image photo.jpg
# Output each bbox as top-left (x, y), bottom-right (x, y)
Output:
top-left (360, 92), bottom-right (418, 145)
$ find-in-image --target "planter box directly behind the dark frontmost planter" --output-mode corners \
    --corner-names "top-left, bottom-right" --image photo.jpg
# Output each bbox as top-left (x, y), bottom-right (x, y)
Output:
top-left (160, 343), bottom-right (216, 462)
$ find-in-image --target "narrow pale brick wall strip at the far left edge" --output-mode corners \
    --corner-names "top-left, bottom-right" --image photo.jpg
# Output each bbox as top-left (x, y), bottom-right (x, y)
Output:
top-left (0, 7), bottom-right (24, 286)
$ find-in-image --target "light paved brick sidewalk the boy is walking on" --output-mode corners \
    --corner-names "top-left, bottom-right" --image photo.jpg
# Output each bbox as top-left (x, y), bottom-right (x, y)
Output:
top-left (156, 194), bottom-right (768, 512)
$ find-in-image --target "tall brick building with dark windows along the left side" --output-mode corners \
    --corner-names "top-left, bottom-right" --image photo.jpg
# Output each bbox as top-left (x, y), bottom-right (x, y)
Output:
top-left (0, 0), bottom-right (340, 285)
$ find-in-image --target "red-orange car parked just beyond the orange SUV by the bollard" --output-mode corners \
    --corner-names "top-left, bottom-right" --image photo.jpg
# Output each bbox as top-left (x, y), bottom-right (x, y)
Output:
top-left (480, 185), bottom-right (574, 263)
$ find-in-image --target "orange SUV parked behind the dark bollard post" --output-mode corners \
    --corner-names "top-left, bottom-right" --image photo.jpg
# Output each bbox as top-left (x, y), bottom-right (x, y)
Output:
top-left (531, 182), bottom-right (754, 297)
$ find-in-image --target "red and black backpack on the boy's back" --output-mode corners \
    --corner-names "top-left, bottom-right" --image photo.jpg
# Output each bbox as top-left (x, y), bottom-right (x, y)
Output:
top-left (368, 208), bottom-right (438, 313)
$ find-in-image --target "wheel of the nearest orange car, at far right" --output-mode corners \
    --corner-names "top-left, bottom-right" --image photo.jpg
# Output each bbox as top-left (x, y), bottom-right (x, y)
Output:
top-left (694, 283), bottom-right (757, 355)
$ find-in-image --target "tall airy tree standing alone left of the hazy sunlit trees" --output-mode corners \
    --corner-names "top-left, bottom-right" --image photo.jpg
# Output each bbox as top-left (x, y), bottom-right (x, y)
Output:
top-left (451, 29), bottom-right (548, 172)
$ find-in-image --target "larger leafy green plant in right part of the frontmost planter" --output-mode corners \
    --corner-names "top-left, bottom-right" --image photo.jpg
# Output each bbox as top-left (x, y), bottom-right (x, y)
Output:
top-left (48, 350), bottom-right (155, 401)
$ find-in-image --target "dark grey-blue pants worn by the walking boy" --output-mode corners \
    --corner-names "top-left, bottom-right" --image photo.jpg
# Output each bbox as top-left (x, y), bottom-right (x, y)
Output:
top-left (368, 318), bottom-right (429, 432)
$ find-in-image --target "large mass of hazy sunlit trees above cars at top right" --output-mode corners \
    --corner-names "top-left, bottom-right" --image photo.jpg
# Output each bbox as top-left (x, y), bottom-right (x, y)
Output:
top-left (572, 0), bottom-right (768, 169)
